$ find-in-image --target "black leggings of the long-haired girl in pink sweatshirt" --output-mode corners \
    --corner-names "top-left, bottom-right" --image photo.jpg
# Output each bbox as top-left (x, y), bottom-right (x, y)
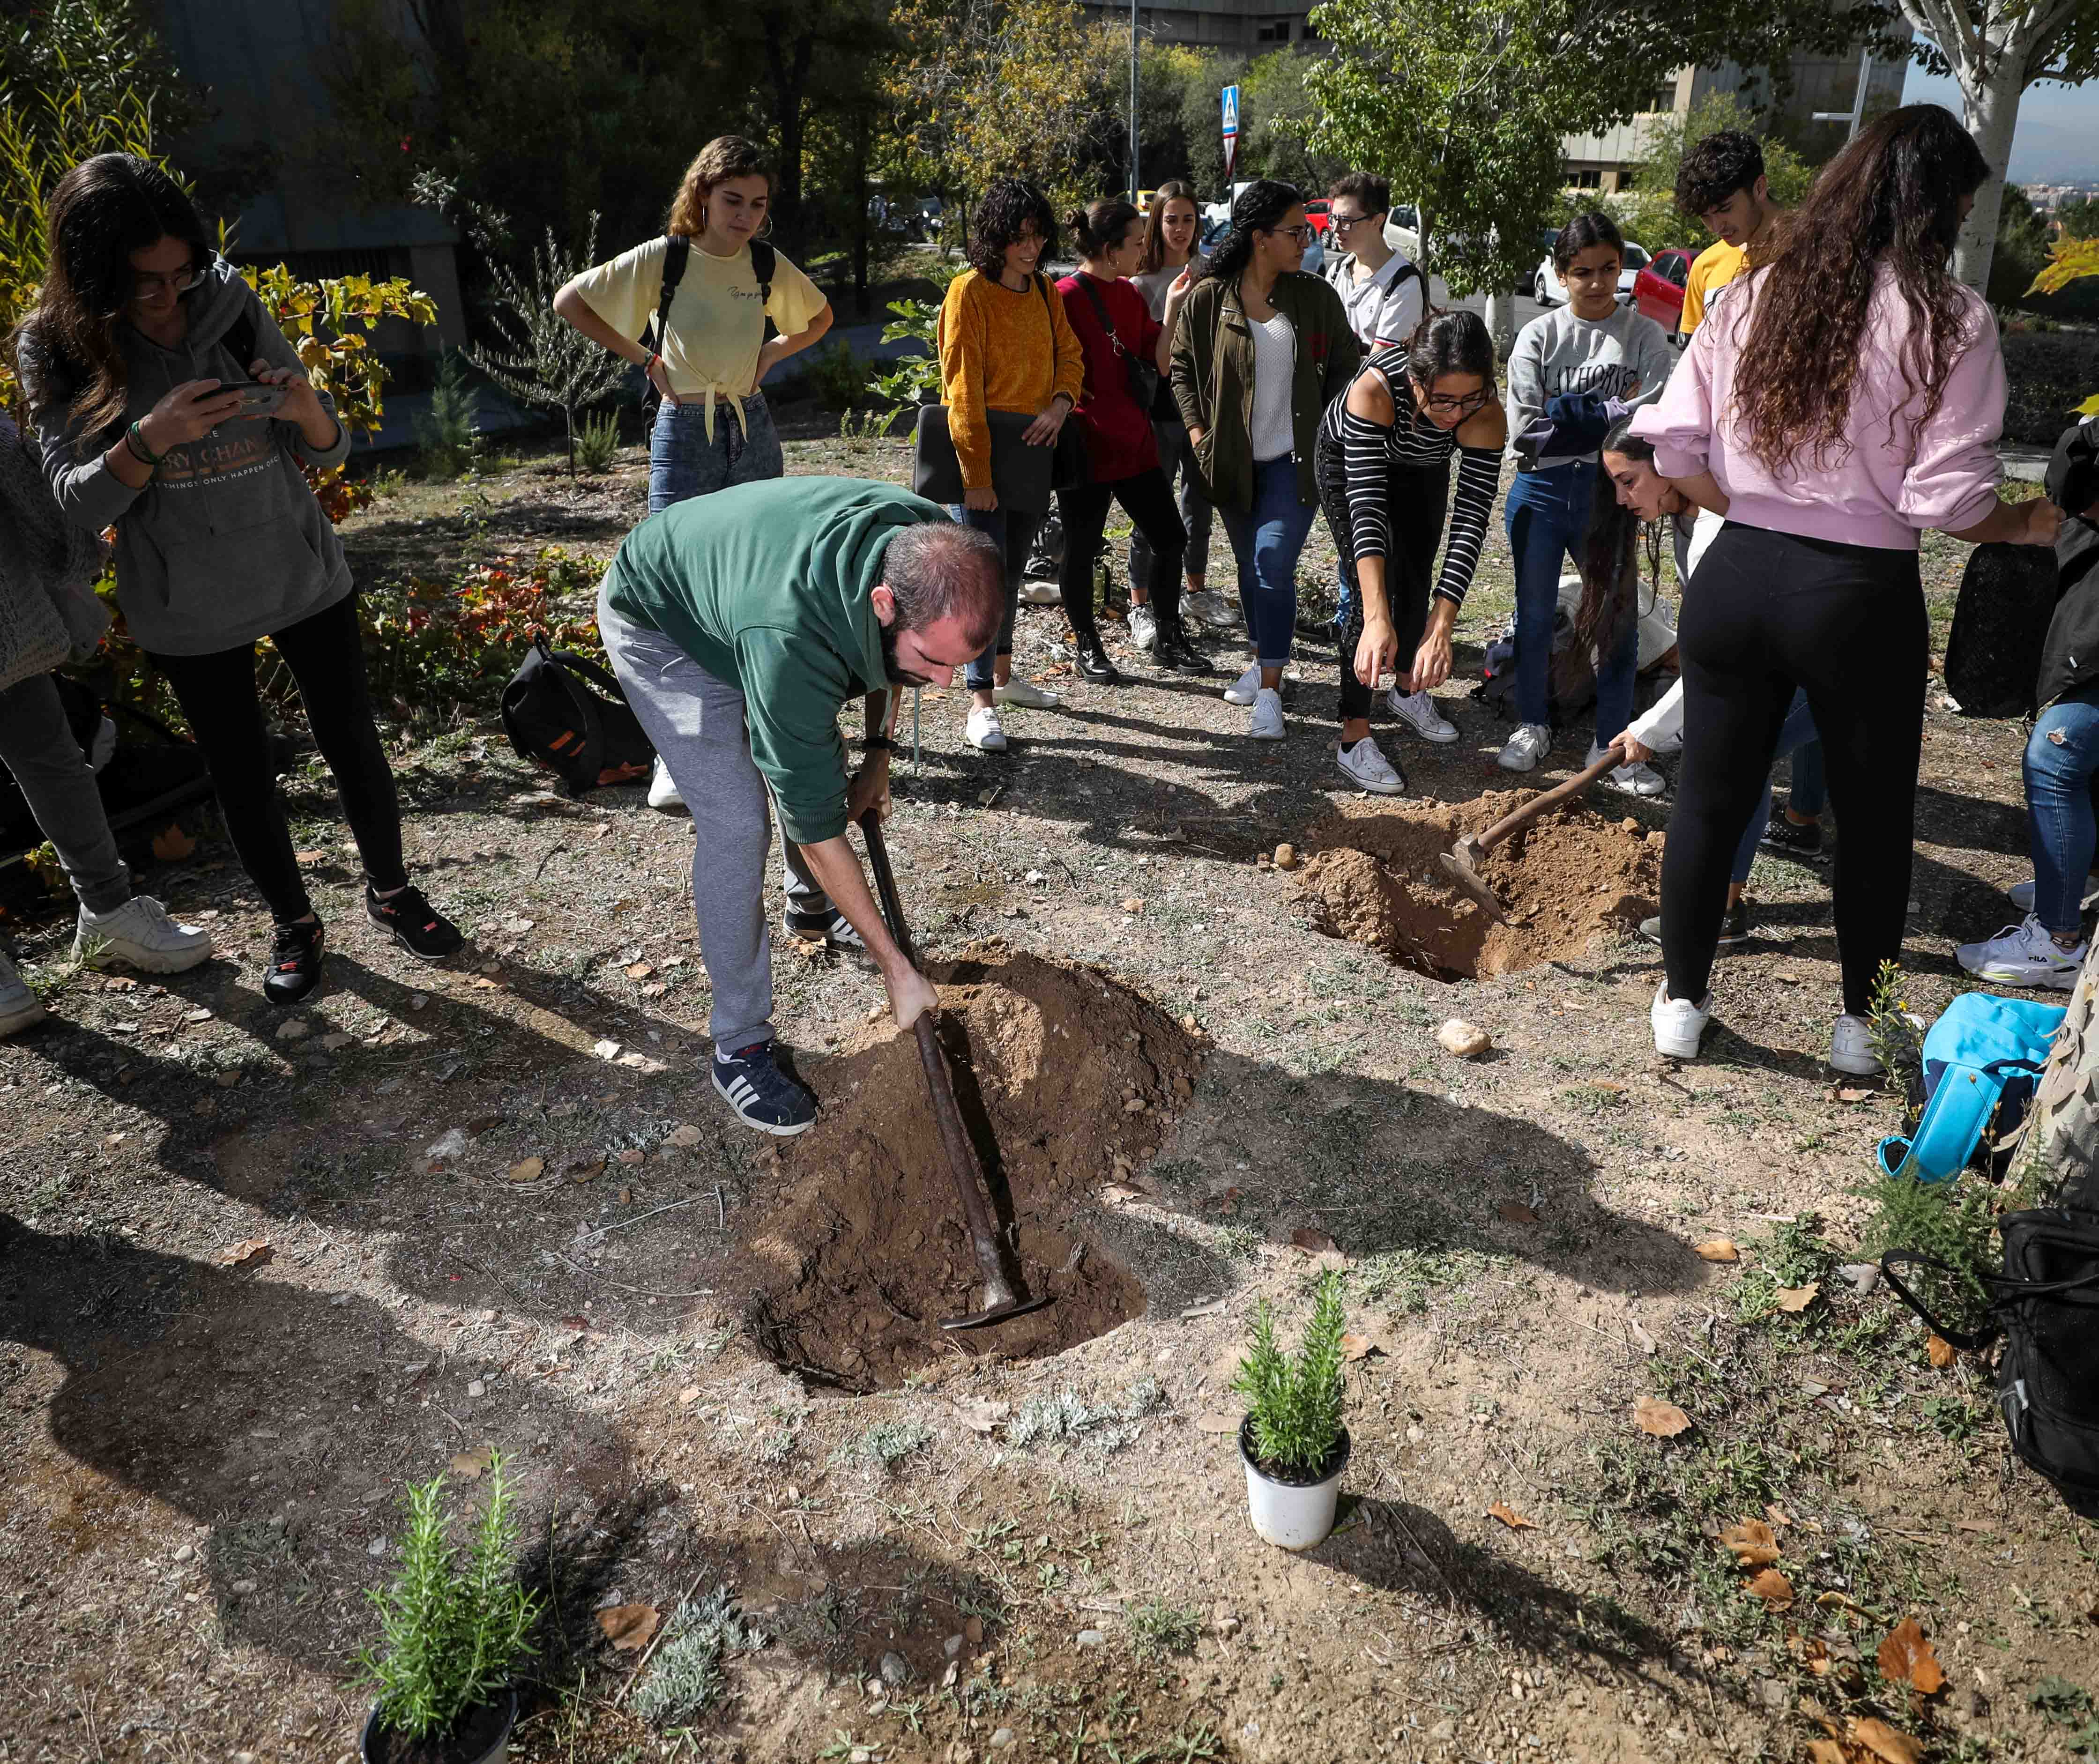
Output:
top-left (1662, 522), bottom-right (1929, 1015)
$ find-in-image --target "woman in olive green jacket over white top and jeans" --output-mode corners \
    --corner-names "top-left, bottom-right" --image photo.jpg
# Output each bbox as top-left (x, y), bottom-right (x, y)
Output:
top-left (1173, 180), bottom-right (1362, 741)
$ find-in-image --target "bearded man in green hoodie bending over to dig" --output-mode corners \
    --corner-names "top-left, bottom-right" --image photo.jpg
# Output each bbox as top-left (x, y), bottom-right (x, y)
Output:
top-left (598, 478), bottom-right (1003, 1137)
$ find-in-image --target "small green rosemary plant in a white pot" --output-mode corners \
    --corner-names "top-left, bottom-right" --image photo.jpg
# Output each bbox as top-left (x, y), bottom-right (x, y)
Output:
top-left (1232, 1269), bottom-right (1347, 1550)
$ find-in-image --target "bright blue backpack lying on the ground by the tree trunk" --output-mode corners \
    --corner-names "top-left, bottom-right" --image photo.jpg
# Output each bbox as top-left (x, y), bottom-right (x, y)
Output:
top-left (1876, 992), bottom-right (2065, 1183)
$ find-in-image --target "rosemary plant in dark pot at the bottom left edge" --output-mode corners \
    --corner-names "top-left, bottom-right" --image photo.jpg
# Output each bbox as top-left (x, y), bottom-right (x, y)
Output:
top-left (357, 1452), bottom-right (539, 1764)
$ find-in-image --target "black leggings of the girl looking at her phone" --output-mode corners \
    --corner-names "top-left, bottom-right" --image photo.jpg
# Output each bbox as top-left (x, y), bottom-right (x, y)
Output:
top-left (151, 593), bottom-right (407, 925)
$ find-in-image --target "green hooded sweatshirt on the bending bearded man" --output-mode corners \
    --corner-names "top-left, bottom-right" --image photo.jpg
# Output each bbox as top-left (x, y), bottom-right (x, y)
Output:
top-left (604, 478), bottom-right (946, 845)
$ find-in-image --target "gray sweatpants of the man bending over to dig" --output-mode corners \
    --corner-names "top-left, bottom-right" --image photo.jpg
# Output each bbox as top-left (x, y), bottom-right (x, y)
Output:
top-left (598, 593), bottom-right (829, 1053)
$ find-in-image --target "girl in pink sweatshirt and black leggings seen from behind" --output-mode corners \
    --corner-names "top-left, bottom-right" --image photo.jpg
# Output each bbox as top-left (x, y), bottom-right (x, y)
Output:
top-left (1633, 105), bottom-right (2061, 1074)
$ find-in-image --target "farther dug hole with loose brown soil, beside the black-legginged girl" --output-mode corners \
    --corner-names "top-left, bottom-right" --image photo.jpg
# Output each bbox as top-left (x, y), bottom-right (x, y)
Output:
top-left (1302, 791), bottom-right (1660, 979)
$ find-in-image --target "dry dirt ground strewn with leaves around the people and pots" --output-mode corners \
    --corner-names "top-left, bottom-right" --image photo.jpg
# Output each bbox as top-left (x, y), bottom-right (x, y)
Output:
top-left (0, 417), bottom-right (2099, 1764)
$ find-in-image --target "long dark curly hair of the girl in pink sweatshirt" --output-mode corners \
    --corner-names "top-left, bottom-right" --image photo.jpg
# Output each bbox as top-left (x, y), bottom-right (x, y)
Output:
top-left (1734, 105), bottom-right (1990, 472)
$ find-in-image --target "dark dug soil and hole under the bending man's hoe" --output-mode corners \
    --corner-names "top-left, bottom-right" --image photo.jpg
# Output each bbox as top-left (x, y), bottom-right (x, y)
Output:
top-left (749, 948), bottom-right (1203, 1388)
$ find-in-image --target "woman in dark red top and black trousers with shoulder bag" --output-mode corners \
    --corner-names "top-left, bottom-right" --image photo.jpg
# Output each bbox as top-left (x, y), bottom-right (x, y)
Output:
top-left (1056, 199), bottom-right (1209, 686)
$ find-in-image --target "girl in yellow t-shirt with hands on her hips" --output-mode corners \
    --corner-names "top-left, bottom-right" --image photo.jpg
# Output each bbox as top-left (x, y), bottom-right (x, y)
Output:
top-left (554, 134), bottom-right (831, 514)
